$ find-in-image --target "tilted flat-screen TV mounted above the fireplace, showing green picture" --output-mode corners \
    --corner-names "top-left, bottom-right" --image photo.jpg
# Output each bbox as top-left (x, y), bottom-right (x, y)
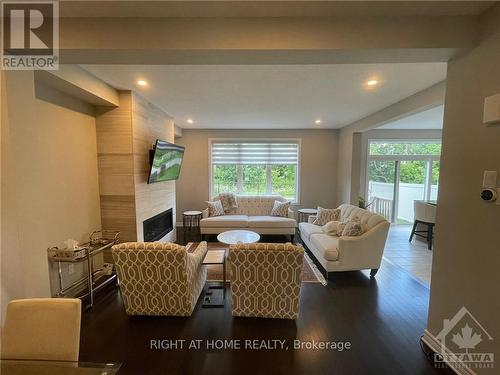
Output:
top-left (148, 139), bottom-right (184, 184)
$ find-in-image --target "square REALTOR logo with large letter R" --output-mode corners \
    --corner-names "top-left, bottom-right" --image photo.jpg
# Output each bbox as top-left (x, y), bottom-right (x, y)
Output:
top-left (1, 1), bottom-right (59, 70)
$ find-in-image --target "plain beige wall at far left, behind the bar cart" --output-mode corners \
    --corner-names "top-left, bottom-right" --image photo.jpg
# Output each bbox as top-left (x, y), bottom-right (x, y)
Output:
top-left (1, 71), bottom-right (101, 320)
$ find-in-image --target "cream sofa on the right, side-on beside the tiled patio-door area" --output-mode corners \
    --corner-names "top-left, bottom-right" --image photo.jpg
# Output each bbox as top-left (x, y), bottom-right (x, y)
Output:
top-left (299, 204), bottom-right (390, 276)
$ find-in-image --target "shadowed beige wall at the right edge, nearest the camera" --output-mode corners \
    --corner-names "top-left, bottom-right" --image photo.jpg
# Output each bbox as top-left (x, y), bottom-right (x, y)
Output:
top-left (428, 6), bottom-right (500, 364)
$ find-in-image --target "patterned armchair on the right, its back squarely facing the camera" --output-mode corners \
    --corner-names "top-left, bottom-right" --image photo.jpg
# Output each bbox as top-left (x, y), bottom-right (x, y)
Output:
top-left (229, 243), bottom-right (304, 319)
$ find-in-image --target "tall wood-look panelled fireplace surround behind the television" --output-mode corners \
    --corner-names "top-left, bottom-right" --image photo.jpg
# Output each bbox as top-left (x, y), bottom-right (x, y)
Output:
top-left (96, 91), bottom-right (175, 250)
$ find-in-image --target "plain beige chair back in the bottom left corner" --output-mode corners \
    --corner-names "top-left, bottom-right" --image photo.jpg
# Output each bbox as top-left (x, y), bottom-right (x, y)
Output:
top-left (2, 298), bottom-right (82, 362)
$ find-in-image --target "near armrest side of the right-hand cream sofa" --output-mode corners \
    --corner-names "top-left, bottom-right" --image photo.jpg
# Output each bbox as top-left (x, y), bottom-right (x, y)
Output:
top-left (338, 222), bottom-right (390, 269)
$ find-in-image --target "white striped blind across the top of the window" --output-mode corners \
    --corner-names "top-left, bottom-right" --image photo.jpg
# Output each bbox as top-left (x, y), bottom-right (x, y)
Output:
top-left (212, 141), bottom-right (299, 165)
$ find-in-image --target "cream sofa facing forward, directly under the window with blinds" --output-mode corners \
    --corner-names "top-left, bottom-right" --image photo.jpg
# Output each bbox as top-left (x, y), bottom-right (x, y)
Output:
top-left (200, 195), bottom-right (297, 239)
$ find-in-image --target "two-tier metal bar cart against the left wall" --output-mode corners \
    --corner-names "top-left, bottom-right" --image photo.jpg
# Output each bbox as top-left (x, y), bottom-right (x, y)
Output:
top-left (47, 230), bottom-right (120, 309)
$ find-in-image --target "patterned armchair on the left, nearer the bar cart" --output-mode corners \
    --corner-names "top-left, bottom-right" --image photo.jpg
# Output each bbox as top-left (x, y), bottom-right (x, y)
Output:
top-left (112, 242), bottom-right (207, 316)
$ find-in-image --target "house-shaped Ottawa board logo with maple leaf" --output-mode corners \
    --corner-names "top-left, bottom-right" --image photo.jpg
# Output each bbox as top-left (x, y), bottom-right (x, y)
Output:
top-left (434, 307), bottom-right (494, 369)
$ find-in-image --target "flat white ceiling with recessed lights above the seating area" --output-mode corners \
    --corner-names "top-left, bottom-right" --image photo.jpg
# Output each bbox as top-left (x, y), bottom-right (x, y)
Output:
top-left (83, 63), bottom-right (446, 129)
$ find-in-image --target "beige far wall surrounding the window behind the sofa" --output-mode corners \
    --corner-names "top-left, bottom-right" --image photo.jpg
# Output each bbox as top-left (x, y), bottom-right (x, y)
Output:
top-left (176, 129), bottom-right (338, 221)
